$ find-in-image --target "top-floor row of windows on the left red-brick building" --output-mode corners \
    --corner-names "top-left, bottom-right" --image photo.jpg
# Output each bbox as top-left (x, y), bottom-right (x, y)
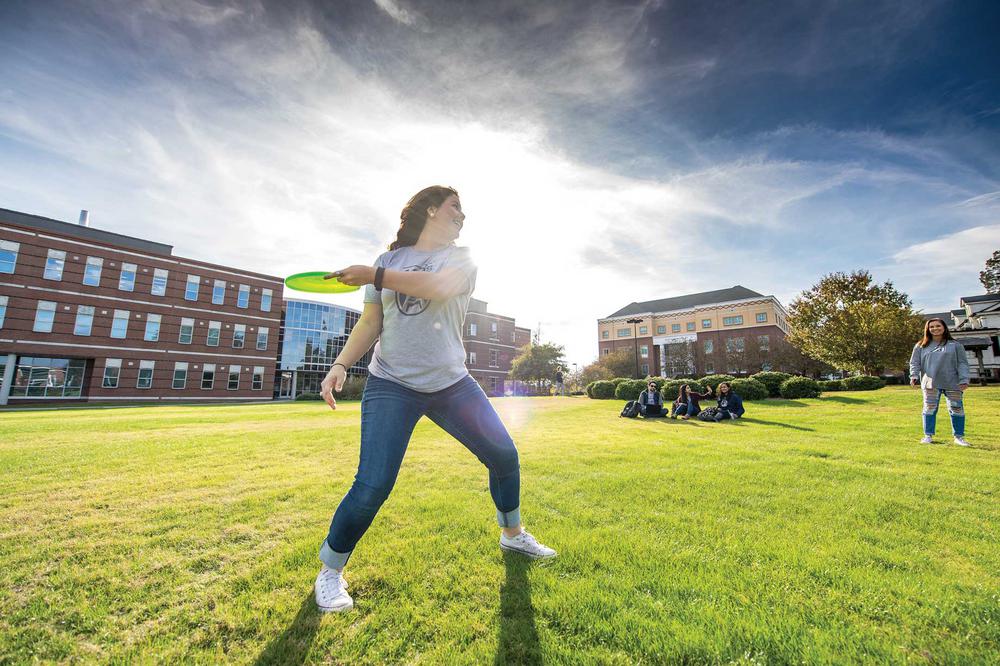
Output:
top-left (0, 240), bottom-right (273, 312)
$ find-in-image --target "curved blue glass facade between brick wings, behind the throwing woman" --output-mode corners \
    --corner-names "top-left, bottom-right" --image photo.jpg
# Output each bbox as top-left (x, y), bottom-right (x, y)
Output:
top-left (275, 300), bottom-right (371, 398)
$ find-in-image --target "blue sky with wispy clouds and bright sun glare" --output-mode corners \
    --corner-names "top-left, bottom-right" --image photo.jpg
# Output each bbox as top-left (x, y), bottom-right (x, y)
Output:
top-left (0, 0), bottom-right (1000, 365)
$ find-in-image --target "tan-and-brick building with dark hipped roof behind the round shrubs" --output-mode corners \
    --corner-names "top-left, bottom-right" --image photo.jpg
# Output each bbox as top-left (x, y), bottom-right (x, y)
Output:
top-left (597, 285), bottom-right (788, 377)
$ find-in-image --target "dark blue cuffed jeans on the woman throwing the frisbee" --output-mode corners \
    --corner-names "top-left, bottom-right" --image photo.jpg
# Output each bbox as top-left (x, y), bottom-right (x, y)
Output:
top-left (319, 375), bottom-right (521, 569)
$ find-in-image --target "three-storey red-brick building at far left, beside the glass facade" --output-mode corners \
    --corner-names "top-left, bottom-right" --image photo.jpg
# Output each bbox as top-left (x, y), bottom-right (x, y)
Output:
top-left (0, 209), bottom-right (283, 404)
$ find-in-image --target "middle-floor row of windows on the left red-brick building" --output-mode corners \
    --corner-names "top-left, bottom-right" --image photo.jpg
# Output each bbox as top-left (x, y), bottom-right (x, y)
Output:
top-left (24, 296), bottom-right (270, 351)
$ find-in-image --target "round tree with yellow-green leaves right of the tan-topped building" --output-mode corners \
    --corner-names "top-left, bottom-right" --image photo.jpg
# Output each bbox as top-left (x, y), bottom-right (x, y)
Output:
top-left (788, 271), bottom-right (923, 374)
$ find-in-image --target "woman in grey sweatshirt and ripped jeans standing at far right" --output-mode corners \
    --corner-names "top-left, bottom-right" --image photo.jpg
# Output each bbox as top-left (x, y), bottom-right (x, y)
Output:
top-left (910, 319), bottom-right (969, 446)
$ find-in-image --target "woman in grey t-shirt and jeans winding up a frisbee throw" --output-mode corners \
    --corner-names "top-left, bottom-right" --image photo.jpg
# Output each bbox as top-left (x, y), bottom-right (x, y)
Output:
top-left (315, 186), bottom-right (556, 611)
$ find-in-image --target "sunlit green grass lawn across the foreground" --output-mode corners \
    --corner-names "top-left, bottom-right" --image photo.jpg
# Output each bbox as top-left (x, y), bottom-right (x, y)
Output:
top-left (0, 387), bottom-right (1000, 664)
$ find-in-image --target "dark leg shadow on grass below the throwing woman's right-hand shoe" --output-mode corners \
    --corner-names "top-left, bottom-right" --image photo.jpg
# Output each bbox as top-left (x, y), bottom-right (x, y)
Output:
top-left (493, 552), bottom-right (542, 666)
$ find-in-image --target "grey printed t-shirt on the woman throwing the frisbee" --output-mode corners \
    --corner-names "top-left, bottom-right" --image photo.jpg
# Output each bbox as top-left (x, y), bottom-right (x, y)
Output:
top-left (365, 245), bottom-right (477, 393)
